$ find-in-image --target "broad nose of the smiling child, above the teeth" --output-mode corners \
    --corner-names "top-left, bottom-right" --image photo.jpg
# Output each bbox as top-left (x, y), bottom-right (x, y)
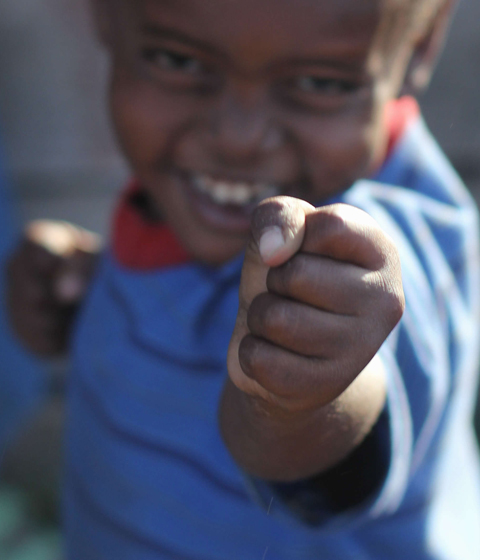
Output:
top-left (210, 84), bottom-right (283, 165)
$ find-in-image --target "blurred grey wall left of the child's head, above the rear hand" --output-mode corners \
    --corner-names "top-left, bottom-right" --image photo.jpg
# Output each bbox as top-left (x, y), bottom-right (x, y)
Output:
top-left (0, 0), bottom-right (125, 231)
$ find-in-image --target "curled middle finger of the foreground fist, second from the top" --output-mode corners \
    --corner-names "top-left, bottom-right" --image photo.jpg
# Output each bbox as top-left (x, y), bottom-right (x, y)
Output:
top-left (267, 253), bottom-right (378, 315)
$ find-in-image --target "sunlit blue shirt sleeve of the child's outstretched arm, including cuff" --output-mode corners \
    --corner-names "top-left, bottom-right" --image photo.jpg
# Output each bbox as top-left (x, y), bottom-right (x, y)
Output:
top-left (246, 173), bottom-right (479, 526)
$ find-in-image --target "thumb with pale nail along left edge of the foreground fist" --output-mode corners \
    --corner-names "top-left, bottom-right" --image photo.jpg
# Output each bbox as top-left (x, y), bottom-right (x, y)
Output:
top-left (228, 196), bottom-right (315, 397)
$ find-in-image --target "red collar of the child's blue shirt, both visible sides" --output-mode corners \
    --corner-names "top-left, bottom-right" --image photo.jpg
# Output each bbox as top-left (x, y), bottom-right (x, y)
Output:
top-left (113, 97), bottom-right (420, 271)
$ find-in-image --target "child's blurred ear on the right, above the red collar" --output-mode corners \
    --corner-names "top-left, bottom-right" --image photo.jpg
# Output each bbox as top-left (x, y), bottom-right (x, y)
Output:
top-left (402, 0), bottom-right (457, 95)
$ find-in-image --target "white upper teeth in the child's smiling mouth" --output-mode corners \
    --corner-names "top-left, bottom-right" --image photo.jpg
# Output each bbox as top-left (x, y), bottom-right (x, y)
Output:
top-left (193, 175), bottom-right (279, 206)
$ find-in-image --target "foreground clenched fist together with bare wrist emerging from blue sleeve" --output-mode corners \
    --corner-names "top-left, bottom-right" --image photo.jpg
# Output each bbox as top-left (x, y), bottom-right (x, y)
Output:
top-left (220, 197), bottom-right (404, 479)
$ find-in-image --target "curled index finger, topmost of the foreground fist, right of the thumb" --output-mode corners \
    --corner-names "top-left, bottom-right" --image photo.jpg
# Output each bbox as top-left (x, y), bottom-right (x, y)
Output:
top-left (302, 204), bottom-right (395, 270)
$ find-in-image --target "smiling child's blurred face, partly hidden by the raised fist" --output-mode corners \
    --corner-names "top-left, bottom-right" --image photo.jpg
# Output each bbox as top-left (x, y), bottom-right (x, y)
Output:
top-left (102, 0), bottom-right (420, 263)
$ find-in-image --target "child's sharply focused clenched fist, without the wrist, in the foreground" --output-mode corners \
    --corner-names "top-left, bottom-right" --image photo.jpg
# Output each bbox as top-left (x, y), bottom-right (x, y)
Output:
top-left (228, 197), bottom-right (404, 411)
